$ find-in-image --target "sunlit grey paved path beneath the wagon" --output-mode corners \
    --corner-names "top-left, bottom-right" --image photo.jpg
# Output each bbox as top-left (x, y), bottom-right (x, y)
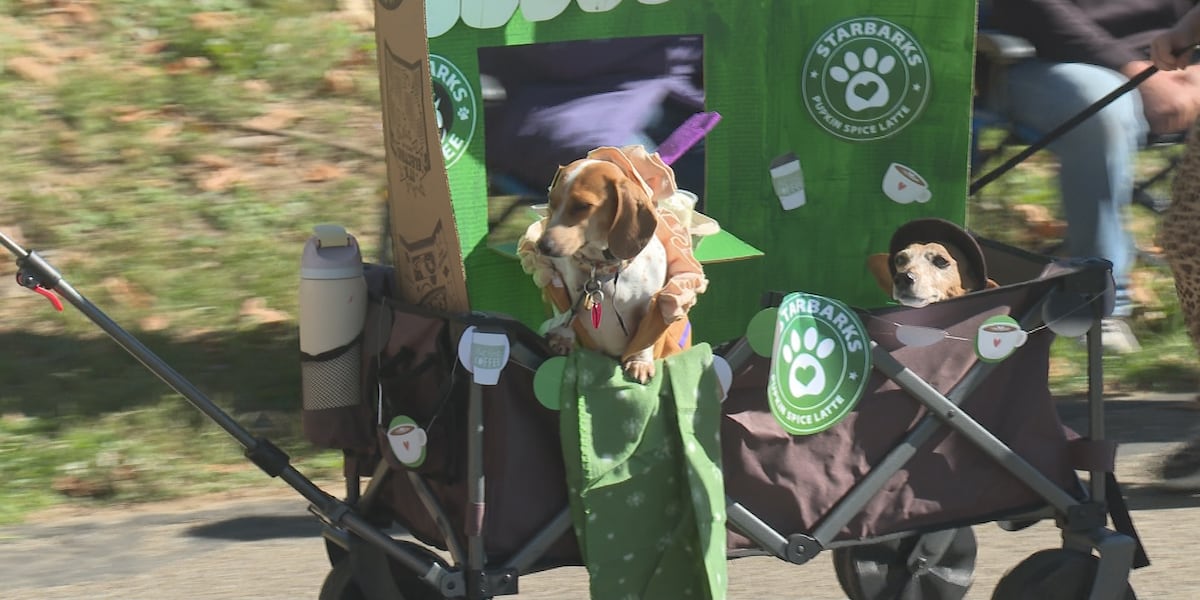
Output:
top-left (0, 396), bottom-right (1200, 600)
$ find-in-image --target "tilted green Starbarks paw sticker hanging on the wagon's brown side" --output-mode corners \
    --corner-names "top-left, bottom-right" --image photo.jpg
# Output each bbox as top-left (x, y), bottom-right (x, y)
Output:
top-left (767, 293), bottom-right (871, 436)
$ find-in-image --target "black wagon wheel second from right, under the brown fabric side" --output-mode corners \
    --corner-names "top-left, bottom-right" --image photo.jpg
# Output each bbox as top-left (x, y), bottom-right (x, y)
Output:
top-left (833, 527), bottom-right (976, 600)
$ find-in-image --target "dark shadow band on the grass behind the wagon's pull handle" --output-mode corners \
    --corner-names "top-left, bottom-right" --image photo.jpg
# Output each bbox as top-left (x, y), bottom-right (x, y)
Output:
top-left (0, 324), bottom-right (300, 416)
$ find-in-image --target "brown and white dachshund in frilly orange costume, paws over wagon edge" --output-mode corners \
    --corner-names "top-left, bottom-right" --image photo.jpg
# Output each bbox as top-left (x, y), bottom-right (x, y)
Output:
top-left (524, 146), bottom-right (707, 383)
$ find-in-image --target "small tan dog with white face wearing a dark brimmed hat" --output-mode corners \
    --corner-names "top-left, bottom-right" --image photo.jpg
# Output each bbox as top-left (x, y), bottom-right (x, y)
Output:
top-left (868, 218), bottom-right (996, 307)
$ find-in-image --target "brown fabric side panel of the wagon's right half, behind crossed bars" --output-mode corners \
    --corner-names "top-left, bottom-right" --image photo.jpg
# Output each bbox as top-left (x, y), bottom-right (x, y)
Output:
top-left (721, 282), bottom-right (1081, 548)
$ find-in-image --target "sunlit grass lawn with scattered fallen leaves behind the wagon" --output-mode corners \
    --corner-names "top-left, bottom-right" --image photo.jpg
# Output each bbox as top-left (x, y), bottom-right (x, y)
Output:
top-left (0, 0), bottom-right (1200, 523)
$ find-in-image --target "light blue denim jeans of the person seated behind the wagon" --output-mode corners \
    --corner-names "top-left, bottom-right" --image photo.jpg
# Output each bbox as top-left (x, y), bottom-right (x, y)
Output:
top-left (1003, 60), bottom-right (1150, 317)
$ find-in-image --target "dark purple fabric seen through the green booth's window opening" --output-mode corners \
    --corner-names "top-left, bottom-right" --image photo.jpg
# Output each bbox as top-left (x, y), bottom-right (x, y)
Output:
top-left (480, 36), bottom-right (704, 191)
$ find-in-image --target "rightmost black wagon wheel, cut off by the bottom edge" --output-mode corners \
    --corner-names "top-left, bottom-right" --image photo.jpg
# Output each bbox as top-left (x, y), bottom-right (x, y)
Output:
top-left (991, 548), bottom-right (1136, 600)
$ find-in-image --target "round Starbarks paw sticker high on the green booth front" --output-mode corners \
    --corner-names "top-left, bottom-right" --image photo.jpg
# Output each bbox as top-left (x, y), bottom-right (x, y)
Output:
top-left (800, 17), bottom-right (930, 142)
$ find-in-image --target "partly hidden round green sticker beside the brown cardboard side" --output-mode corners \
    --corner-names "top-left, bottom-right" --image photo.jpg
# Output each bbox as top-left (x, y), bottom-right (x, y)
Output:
top-left (430, 54), bottom-right (479, 168)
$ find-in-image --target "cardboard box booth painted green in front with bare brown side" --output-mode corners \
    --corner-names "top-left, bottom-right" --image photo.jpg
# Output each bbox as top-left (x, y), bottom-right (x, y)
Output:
top-left (377, 0), bottom-right (974, 342)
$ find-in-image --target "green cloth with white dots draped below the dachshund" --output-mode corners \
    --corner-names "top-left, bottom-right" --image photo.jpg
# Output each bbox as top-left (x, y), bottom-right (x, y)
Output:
top-left (560, 344), bottom-right (726, 600)
